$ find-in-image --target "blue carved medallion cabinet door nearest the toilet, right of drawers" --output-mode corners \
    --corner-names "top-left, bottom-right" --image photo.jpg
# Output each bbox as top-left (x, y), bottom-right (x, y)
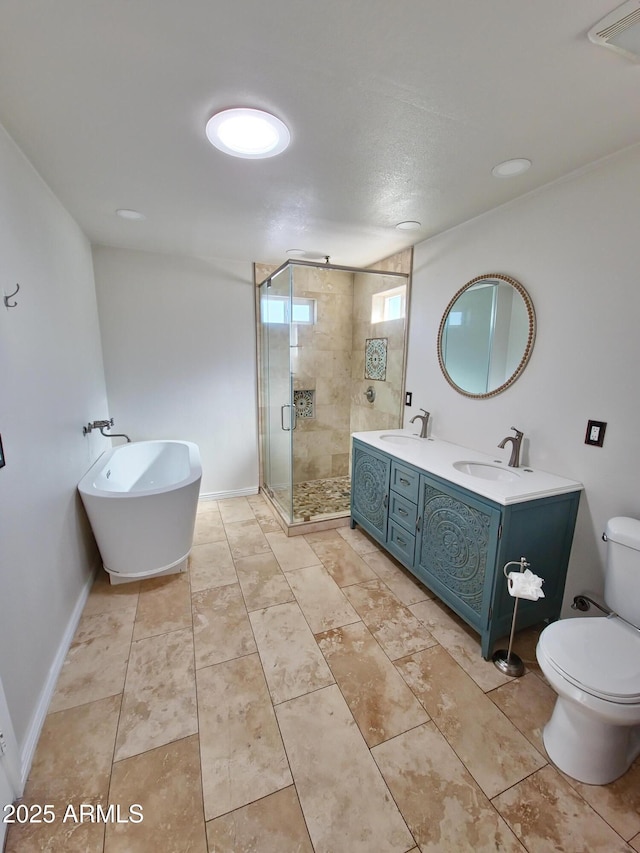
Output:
top-left (416, 476), bottom-right (501, 631)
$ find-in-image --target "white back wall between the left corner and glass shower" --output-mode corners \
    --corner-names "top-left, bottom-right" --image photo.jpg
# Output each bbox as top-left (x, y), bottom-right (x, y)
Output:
top-left (93, 246), bottom-right (258, 497)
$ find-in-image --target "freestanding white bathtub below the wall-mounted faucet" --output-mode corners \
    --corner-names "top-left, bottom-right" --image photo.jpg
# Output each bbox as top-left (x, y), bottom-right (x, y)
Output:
top-left (78, 441), bottom-right (202, 583)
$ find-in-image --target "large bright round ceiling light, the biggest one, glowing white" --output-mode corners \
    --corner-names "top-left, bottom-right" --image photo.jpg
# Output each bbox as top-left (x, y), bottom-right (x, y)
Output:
top-left (206, 107), bottom-right (291, 160)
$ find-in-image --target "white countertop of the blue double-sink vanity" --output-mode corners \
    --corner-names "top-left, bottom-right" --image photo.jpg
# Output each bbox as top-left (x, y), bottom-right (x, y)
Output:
top-left (353, 429), bottom-right (583, 506)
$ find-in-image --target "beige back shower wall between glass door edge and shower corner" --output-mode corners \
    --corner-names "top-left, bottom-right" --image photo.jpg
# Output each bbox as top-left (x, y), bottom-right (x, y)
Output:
top-left (291, 267), bottom-right (353, 483)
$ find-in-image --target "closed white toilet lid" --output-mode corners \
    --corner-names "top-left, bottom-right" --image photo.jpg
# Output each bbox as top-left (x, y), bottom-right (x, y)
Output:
top-left (540, 617), bottom-right (640, 704)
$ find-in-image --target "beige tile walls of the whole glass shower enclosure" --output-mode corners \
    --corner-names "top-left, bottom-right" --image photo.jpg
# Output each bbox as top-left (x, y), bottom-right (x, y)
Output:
top-left (254, 249), bottom-right (412, 500)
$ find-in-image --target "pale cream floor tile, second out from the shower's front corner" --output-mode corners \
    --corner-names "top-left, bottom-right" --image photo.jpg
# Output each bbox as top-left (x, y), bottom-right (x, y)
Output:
top-left (287, 566), bottom-right (360, 634)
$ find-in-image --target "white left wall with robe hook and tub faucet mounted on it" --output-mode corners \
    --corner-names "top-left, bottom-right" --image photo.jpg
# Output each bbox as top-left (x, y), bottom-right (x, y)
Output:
top-left (0, 123), bottom-right (108, 770)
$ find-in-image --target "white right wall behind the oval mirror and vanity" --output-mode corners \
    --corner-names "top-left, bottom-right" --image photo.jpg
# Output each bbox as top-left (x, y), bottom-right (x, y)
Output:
top-left (405, 147), bottom-right (640, 615)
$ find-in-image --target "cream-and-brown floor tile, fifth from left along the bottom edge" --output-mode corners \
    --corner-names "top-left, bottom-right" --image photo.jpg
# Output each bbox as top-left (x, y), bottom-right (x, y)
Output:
top-left (372, 723), bottom-right (525, 853)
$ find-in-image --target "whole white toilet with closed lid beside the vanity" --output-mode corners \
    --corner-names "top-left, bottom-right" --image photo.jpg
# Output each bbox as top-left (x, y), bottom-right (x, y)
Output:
top-left (536, 518), bottom-right (640, 785)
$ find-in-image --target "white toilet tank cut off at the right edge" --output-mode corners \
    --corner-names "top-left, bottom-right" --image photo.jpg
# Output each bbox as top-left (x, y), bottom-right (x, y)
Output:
top-left (604, 517), bottom-right (640, 626)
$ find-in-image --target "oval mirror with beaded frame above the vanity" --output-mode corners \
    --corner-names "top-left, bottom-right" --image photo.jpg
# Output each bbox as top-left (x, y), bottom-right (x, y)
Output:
top-left (438, 273), bottom-right (536, 398)
